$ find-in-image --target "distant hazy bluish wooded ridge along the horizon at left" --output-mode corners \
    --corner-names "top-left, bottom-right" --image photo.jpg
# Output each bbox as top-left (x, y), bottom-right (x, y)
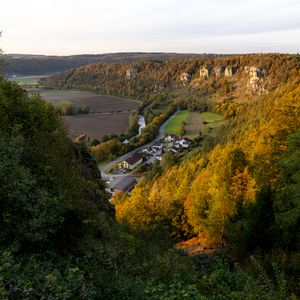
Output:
top-left (2, 52), bottom-right (215, 76)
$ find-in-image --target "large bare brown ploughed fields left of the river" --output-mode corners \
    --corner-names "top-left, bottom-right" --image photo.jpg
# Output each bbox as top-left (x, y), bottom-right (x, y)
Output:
top-left (28, 89), bottom-right (139, 139)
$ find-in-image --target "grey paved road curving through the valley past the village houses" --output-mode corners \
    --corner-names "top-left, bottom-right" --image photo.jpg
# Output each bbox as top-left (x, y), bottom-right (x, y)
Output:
top-left (99, 110), bottom-right (180, 180)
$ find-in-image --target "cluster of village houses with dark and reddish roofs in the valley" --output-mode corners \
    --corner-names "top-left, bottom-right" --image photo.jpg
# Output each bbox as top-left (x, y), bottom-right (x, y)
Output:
top-left (106, 134), bottom-right (191, 195)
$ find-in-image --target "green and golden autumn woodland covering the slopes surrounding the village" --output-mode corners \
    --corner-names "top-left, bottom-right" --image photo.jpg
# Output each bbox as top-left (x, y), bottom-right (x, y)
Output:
top-left (0, 54), bottom-right (300, 300)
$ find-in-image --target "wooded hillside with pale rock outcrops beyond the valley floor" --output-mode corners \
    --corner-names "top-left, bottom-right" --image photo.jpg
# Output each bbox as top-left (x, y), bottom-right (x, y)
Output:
top-left (42, 54), bottom-right (299, 101)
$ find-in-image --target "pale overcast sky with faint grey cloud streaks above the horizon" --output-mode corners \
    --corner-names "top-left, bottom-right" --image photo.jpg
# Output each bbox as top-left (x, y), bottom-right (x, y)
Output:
top-left (0, 0), bottom-right (300, 55)
